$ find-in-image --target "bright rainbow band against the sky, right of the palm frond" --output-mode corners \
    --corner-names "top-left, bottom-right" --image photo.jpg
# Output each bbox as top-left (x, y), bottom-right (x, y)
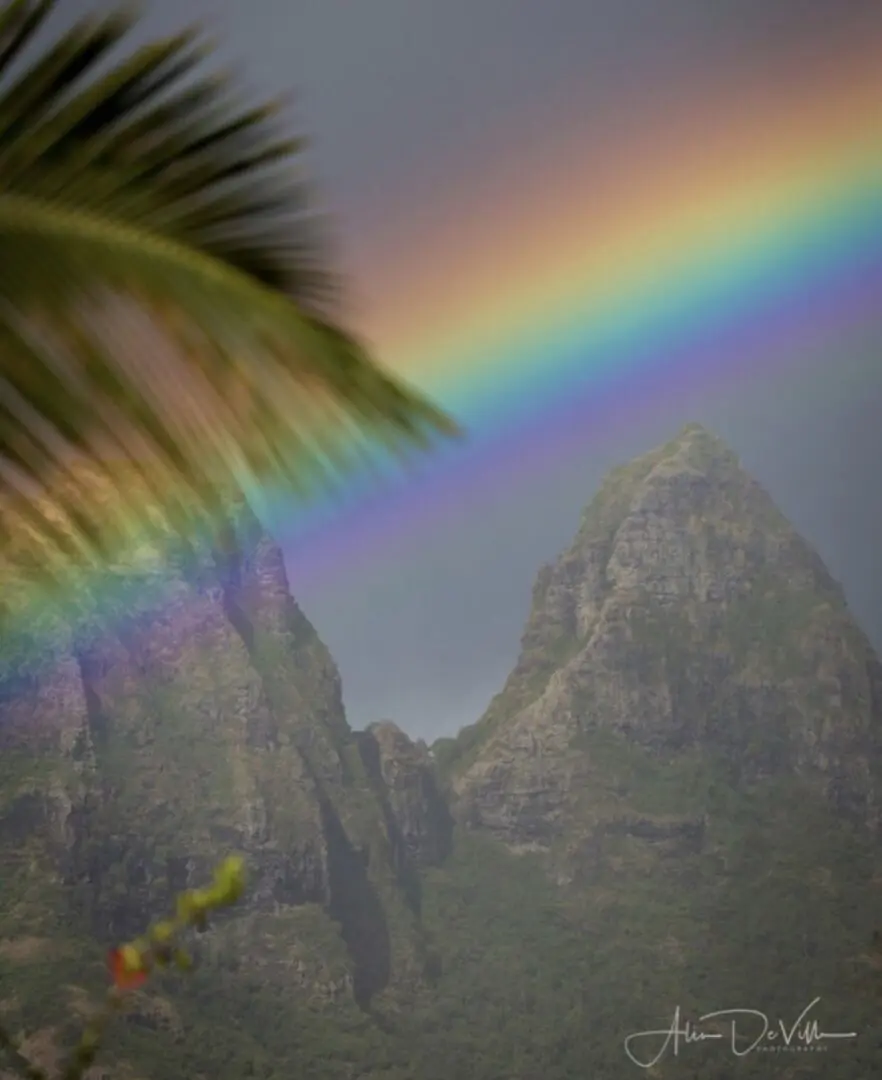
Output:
top-left (270, 33), bottom-right (882, 580)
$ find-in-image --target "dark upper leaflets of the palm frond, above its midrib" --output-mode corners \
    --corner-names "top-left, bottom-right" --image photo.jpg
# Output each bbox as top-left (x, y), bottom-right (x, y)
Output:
top-left (0, 2), bottom-right (336, 305)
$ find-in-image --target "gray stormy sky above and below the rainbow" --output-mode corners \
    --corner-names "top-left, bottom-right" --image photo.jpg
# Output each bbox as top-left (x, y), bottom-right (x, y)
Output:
top-left (67, 0), bottom-right (882, 737)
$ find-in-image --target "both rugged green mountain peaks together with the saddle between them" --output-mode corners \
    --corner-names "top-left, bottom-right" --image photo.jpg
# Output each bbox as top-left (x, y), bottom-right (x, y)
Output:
top-left (0, 426), bottom-right (882, 1080)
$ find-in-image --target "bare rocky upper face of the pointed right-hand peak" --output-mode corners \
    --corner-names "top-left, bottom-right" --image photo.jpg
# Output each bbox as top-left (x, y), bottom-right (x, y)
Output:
top-left (446, 426), bottom-right (882, 847)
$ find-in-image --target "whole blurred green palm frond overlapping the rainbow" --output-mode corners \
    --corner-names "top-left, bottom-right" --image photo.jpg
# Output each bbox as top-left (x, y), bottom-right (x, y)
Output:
top-left (0, 0), bottom-right (464, 591)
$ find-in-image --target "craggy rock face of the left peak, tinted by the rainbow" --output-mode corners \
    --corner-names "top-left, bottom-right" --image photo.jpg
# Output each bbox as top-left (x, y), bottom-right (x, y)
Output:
top-left (0, 505), bottom-right (449, 1028)
